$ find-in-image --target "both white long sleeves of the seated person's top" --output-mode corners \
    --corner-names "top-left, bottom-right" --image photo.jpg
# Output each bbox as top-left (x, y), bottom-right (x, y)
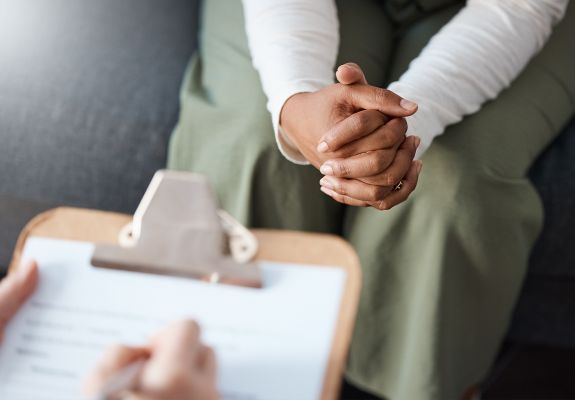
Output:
top-left (243, 0), bottom-right (569, 164)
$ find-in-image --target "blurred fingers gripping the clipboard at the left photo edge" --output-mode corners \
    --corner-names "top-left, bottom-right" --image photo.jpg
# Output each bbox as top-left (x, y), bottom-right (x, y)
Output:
top-left (0, 262), bottom-right (38, 342)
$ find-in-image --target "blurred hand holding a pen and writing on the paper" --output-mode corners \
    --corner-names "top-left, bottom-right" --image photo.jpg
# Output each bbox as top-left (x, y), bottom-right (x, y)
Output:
top-left (86, 321), bottom-right (219, 400)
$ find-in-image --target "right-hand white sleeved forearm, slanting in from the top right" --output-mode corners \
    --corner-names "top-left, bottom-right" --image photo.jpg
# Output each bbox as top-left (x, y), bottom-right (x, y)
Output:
top-left (389, 0), bottom-right (568, 157)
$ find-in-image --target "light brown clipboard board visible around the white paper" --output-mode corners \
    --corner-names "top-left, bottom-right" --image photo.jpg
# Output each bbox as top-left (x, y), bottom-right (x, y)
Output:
top-left (10, 171), bottom-right (361, 400)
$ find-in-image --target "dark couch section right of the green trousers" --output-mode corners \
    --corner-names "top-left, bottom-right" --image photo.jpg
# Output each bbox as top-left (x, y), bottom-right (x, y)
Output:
top-left (509, 116), bottom-right (575, 348)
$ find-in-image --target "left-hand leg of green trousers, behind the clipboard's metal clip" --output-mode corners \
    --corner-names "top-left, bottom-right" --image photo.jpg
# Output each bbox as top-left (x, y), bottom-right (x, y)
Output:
top-left (168, 1), bottom-right (343, 233)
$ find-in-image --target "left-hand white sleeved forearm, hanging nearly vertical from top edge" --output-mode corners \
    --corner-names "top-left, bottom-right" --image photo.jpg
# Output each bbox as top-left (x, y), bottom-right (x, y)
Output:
top-left (243, 0), bottom-right (339, 163)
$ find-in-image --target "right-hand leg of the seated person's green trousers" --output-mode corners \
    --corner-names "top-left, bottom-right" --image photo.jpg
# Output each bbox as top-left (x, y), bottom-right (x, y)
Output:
top-left (345, 2), bottom-right (575, 398)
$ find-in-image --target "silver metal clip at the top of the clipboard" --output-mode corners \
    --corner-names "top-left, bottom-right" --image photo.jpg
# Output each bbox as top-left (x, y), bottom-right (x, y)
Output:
top-left (92, 171), bottom-right (262, 287)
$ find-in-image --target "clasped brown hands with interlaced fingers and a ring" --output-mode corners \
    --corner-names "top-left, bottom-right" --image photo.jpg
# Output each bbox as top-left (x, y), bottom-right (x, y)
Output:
top-left (280, 63), bottom-right (422, 210)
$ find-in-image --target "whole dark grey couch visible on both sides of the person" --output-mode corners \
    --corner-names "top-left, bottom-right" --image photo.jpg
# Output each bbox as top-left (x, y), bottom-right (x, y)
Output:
top-left (0, 0), bottom-right (575, 394)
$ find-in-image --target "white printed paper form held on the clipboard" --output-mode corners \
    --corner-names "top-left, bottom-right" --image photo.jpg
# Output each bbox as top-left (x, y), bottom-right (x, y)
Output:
top-left (0, 238), bottom-right (345, 400)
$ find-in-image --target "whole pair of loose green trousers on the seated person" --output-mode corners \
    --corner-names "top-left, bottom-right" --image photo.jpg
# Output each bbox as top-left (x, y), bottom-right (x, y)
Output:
top-left (169, 0), bottom-right (575, 400)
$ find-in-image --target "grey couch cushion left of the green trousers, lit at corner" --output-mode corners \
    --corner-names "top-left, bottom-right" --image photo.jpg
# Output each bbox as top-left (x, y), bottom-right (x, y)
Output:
top-left (0, 0), bottom-right (197, 212)
